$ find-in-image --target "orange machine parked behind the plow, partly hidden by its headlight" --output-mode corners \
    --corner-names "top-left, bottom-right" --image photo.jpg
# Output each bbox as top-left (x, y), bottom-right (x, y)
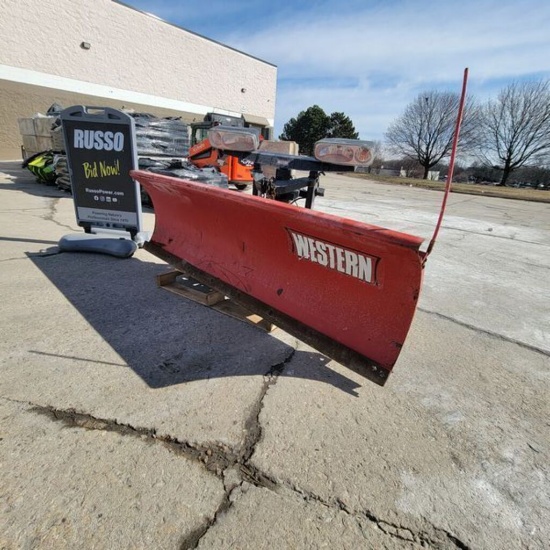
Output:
top-left (189, 113), bottom-right (260, 190)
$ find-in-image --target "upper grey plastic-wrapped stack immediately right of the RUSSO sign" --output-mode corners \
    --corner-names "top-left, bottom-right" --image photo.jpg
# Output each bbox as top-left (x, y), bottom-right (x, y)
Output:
top-left (128, 113), bottom-right (189, 157)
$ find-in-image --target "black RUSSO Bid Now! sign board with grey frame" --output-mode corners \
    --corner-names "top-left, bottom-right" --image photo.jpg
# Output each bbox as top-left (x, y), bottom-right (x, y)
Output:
top-left (61, 105), bottom-right (142, 237)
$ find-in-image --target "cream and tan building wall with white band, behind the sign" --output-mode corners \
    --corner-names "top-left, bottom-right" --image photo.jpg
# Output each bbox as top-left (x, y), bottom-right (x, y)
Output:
top-left (0, 0), bottom-right (277, 159)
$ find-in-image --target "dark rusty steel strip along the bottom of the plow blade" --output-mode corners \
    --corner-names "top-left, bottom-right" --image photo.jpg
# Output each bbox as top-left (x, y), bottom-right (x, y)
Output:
top-left (147, 242), bottom-right (391, 386)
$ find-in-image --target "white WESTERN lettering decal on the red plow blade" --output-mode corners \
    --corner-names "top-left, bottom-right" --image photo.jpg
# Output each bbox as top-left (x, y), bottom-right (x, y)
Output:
top-left (289, 230), bottom-right (376, 283)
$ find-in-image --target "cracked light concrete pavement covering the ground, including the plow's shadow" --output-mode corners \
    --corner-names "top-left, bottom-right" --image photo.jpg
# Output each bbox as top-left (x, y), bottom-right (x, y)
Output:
top-left (0, 162), bottom-right (550, 550)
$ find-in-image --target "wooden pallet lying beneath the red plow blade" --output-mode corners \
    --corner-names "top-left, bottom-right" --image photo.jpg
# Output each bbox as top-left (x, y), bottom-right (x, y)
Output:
top-left (157, 270), bottom-right (275, 332)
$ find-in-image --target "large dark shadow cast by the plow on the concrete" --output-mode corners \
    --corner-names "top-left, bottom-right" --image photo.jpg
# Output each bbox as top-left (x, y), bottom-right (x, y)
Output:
top-left (28, 252), bottom-right (359, 395)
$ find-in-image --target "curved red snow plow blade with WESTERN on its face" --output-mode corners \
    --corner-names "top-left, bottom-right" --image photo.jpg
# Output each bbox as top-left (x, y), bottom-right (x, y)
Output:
top-left (131, 170), bottom-right (425, 385)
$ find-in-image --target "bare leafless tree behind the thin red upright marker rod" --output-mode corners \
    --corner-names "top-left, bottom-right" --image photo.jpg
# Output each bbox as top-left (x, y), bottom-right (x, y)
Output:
top-left (386, 91), bottom-right (478, 179)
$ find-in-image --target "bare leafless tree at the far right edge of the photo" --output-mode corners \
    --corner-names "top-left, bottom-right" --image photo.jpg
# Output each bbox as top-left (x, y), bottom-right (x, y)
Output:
top-left (481, 81), bottom-right (550, 185)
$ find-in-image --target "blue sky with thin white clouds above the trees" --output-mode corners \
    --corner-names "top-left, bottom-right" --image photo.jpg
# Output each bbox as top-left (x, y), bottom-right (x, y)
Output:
top-left (123, 0), bottom-right (550, 140)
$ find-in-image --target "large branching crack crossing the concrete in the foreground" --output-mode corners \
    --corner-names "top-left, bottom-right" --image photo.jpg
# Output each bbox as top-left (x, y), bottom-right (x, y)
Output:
top-left (17, 349), bottom-right (470, 550)
